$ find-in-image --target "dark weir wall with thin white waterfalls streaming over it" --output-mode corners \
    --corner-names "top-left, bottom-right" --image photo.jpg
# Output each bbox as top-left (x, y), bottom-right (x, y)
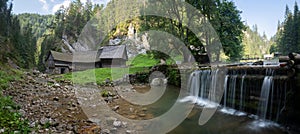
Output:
top-left (188, 67), bottom-right (292, 122)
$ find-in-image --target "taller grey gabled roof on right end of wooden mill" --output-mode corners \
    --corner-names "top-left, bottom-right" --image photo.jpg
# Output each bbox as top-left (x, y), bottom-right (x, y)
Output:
top-left (99, 45), bottom-right (128, 60)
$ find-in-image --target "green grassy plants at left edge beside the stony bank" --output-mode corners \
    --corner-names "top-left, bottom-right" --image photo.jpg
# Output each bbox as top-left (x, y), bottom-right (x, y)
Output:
top-left (0, 65), bottom-right (30, 133)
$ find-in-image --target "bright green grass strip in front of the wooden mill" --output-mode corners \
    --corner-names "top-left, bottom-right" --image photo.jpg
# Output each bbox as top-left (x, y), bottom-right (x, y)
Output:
top-left (58, 54), bottom-right (180, 85)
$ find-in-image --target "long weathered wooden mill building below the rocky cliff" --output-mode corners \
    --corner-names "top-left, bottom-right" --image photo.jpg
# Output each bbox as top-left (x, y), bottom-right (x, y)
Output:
top-left (45, 45), bottom-right (128, 74)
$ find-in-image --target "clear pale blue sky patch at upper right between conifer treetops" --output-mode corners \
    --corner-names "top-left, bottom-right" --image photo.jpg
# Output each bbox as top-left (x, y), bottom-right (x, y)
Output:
top-left (232, 0), bottom-right (300, 38)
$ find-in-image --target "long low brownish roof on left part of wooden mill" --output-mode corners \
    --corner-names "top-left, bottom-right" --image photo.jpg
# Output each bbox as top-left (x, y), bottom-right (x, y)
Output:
top-left (50, 51), bottom-right (100, 63)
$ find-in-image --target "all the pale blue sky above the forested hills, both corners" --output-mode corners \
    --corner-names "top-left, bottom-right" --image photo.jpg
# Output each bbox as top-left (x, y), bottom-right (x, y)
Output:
top-left (13, 0), bottom-right (300, 38)
